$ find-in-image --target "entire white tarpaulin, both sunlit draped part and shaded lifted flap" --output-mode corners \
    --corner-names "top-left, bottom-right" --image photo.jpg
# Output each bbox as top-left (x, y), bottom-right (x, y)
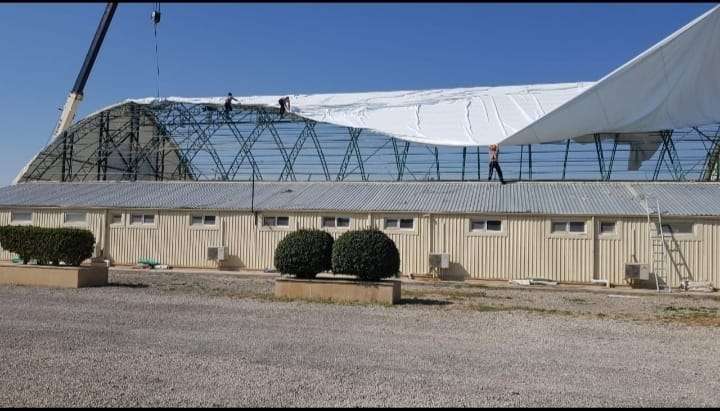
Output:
top-left (76, 6), bottom-right (720, 150)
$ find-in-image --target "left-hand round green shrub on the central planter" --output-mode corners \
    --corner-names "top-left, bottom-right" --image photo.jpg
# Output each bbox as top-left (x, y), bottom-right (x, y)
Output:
top-left (275, 230), bottom-right (333, 278)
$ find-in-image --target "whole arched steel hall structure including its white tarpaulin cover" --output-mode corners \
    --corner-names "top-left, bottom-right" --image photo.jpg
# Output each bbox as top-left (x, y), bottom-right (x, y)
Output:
top-left (16, 6), bottom-right (720, 182)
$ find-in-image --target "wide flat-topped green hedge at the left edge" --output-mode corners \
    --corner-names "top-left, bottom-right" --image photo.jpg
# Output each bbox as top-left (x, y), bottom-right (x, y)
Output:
top-left (0, 226), bottom-right (95, 266)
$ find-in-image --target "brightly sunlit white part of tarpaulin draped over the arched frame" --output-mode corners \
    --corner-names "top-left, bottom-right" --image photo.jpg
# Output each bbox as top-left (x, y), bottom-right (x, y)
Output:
top-left (97, 82), bottom-right (593, 146)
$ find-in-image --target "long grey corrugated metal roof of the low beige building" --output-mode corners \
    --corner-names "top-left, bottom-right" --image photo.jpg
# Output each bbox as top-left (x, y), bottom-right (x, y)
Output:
top-left (0, 181), bottom-right (720, 216)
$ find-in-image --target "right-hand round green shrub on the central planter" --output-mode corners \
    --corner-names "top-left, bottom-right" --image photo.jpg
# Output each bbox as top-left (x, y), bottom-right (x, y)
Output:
top-left (332, 229), bottom-right (400, 281)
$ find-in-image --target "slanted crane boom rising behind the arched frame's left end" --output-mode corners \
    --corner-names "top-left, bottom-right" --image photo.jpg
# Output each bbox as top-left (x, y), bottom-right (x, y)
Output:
top-left (52, 1), bottom-right (117, 138)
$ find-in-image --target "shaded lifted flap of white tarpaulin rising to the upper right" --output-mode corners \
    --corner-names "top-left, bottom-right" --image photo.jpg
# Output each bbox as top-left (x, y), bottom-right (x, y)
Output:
top-left (500, 6), bottom-right (720, 144)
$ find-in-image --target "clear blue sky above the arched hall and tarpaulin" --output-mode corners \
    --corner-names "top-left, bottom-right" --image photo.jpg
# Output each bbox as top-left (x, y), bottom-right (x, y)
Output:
top-left (0, 3), bottom-right (712, 185)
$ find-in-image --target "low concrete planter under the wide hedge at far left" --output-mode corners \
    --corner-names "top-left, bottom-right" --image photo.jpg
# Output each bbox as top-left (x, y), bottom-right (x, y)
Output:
top-left (0, 264), bottom-right (108, 288)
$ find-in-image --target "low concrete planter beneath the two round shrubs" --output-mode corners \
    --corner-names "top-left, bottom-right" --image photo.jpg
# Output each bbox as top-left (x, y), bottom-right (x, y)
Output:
top-left (275, 278), bottom-right (400, 304)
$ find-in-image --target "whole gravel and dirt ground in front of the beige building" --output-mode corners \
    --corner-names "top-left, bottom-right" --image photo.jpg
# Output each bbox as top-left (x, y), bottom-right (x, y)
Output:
top-left (0, 271), bottom-right (720, 406)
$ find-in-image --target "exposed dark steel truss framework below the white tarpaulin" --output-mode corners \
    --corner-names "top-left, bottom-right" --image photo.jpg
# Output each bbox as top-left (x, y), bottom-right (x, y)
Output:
top-left (19, 102), bottom-right (720, 181)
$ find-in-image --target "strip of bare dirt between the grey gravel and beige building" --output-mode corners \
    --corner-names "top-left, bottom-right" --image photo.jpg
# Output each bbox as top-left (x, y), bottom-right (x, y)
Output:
top-left (110, 270), bottom-right (720, 327)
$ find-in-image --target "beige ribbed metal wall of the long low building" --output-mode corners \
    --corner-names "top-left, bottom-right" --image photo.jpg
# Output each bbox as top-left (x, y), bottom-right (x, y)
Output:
top-left (0, 209), bottom-right (720, 286)
